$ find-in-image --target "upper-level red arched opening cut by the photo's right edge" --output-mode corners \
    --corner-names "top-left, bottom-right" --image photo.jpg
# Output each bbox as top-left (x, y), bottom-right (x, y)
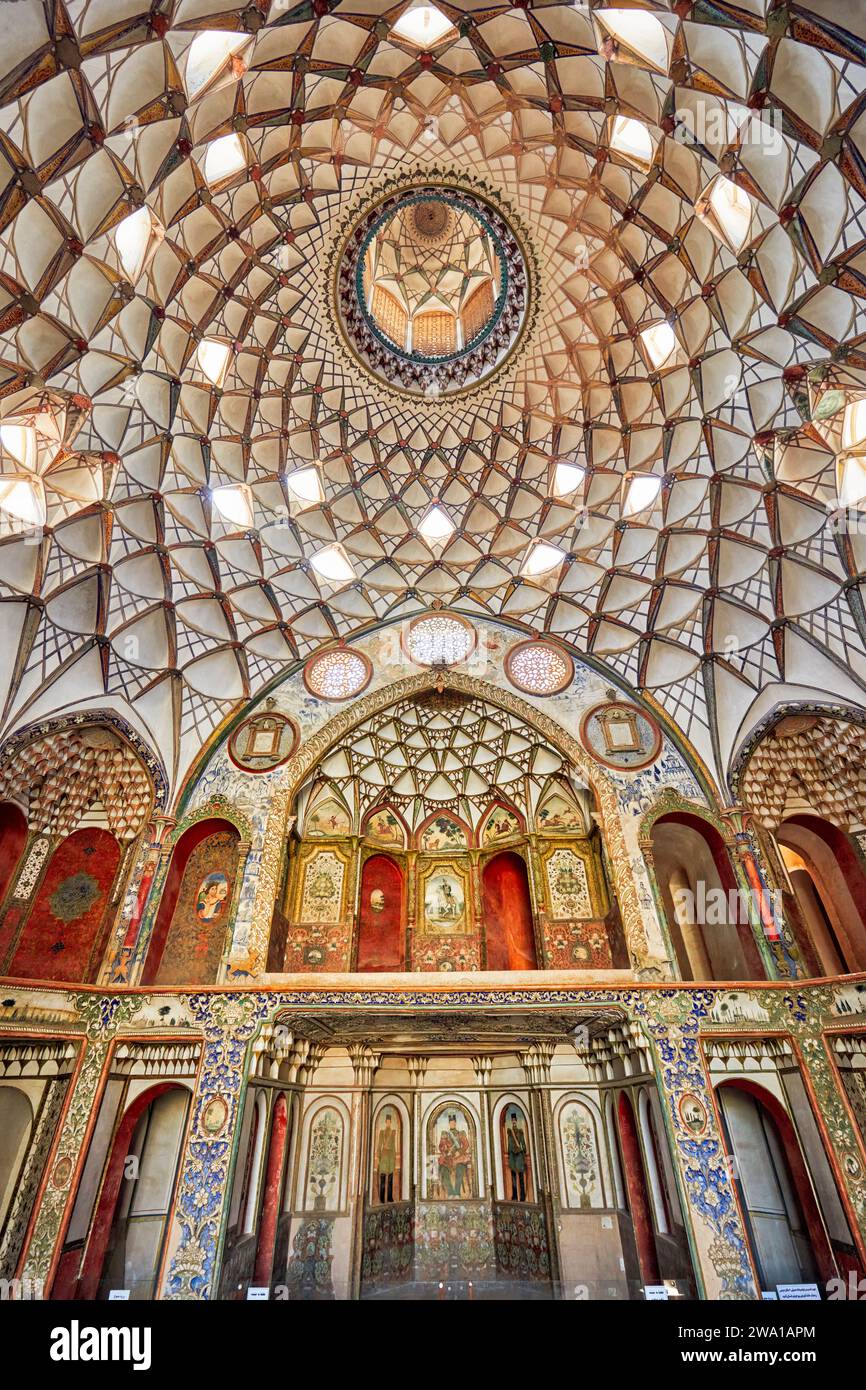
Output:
top-left (776, 815), bottom-right (866, 976)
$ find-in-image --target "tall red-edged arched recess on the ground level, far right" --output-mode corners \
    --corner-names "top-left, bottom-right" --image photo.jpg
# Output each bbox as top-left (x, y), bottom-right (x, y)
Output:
top-left (716, 1077), bottom-right (837, 1290)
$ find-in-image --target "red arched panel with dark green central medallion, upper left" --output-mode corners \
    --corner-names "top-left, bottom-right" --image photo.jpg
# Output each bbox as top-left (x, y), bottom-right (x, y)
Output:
top-left (8, 828), bottom-right (121, 981)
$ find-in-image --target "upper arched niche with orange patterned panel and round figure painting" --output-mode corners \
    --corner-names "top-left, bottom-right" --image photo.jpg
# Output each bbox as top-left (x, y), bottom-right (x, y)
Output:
top-left (142, 817), bottom-right (240, 986)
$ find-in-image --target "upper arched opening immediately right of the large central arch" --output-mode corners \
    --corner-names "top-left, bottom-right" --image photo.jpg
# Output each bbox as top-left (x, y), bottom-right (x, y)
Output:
top-left (649, 810), bottom-right (766, 980)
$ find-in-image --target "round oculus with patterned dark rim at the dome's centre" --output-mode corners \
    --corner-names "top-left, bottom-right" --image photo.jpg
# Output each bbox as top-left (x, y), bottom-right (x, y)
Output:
top-left (334, 182), bottom-right (530, 398)
